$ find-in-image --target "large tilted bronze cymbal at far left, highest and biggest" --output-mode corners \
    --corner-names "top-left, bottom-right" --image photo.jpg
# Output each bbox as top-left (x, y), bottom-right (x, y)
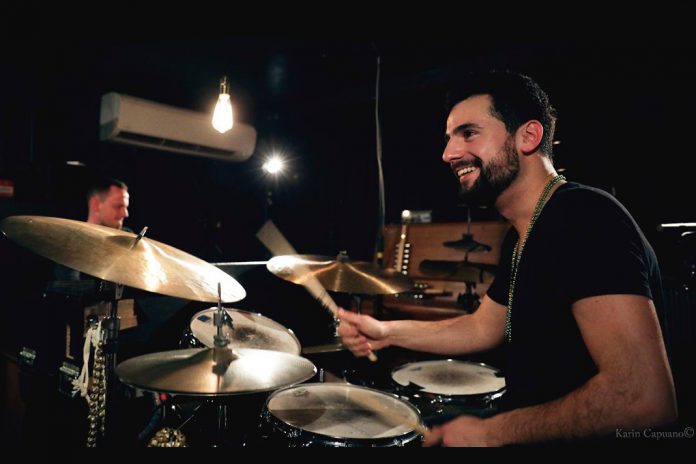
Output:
top-left (0, 216), bottom-right (246, 303)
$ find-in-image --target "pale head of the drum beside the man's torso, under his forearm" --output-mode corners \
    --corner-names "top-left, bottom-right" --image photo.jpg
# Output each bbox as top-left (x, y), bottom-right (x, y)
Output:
top-left (392, 359), bottom-right (505, 396)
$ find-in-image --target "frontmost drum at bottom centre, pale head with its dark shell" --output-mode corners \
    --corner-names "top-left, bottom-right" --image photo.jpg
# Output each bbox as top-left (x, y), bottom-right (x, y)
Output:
top-left (260, 383), bottom-right (421, 448)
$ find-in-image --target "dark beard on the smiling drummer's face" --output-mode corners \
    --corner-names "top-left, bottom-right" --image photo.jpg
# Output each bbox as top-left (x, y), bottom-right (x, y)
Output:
top-left (459, 136), bottom-right (520, 207)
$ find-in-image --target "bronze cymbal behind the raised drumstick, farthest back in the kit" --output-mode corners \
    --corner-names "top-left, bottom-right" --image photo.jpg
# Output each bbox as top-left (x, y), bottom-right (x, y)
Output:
top-left (266, 253), bottom-right (414, 295)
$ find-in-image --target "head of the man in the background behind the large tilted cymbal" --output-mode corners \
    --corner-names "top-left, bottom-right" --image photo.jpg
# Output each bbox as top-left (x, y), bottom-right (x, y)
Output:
top-left (54, 179), bottom-right (131, 280)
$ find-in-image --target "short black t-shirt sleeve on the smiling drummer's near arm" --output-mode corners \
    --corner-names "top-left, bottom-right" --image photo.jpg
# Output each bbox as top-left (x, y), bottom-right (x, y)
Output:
top-left (557, 193), bottom-right (652, 304)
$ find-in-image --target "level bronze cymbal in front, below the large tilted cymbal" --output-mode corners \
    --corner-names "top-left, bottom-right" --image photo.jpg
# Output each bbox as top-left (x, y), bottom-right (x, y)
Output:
top-left (116, 348), bottom-right (317, 395)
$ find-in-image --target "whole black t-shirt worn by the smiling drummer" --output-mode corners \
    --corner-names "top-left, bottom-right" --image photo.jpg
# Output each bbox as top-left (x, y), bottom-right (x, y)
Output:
top-left (488, 182), bottom-right (662, 410)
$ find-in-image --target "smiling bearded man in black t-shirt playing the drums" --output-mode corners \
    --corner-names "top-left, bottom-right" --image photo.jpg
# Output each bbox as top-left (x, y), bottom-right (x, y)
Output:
top-left (339, 73), bottom-right (677, 446)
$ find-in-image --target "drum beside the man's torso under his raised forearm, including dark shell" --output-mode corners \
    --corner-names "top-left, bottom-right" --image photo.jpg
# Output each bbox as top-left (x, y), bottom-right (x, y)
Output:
top-left (391, 359), bottom-right (505, 423)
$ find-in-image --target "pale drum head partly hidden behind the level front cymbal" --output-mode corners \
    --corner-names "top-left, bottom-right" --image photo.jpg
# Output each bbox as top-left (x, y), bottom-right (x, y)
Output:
top-left (191, 308), bottom-right (302, 355)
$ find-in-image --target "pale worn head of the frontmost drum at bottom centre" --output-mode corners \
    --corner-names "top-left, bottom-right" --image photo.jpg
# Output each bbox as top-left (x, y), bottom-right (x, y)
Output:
top-left (267, 383), bottom-right (420, 439)
